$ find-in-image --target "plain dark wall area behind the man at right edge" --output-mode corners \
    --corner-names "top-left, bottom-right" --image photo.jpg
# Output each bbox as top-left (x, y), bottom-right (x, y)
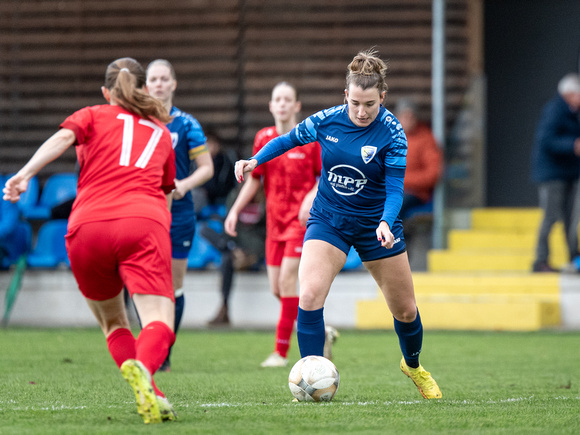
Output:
top-left (484, 0), bottom-right (580, 207)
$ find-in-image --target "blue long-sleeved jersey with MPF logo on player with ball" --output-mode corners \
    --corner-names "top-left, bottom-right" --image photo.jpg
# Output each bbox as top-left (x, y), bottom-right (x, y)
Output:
top-left (252, 104), bottom-right (407, 228)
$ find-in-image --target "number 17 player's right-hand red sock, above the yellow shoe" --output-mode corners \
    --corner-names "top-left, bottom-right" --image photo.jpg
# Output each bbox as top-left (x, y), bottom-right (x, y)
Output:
top-left (135, 321), bottom-right (175, 376)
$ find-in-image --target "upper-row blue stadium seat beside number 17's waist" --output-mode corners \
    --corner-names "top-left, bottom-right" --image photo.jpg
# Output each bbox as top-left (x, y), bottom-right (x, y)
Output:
top-left (22, 172), bottom-right (78, 220)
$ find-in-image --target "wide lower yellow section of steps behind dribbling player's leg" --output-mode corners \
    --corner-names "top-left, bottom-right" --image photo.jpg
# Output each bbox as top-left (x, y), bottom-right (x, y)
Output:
top-left (357, 273), bottom-right (561, 331)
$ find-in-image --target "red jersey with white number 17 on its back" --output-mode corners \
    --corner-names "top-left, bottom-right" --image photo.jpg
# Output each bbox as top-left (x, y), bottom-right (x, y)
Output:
top-left (61, 104), bottom-right (175, 232)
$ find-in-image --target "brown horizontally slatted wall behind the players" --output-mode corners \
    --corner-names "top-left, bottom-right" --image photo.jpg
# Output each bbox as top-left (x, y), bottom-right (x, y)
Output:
top-left (0, 0), bottom-right (469, 178)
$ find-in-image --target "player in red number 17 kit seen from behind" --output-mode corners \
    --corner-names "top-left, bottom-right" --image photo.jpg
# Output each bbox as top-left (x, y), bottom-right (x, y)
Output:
top-left (3, 58), bottom-right (175, 423)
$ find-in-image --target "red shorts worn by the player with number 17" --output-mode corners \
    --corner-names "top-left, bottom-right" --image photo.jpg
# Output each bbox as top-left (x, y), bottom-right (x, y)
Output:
top-left (66, 218), bottom-right (174, 301)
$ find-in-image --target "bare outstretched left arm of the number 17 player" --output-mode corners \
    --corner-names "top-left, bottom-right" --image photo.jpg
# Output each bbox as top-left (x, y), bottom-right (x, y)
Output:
top-left (3, 128), bottom-right (77, 202)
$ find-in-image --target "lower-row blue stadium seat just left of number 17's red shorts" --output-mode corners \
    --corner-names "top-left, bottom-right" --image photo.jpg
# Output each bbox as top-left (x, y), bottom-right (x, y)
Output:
top-left (28, 219), bottom-right (70, 268)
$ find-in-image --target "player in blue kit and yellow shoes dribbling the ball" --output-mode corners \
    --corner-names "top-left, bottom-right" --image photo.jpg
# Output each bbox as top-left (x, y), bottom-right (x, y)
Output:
top-left (235, 50), bottom-right (442, 399)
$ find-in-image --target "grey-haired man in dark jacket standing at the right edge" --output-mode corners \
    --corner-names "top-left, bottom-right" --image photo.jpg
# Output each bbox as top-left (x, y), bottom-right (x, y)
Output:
top-left (531, 73), bottom-right (580, 272)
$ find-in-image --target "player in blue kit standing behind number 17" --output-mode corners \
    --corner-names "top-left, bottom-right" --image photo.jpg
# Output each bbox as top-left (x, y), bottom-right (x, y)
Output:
top-left (147, 59), bottom-right (213, 371)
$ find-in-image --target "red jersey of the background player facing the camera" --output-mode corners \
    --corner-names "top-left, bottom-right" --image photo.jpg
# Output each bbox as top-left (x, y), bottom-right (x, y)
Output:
top-left (252, 127), bottom-right (322, 241)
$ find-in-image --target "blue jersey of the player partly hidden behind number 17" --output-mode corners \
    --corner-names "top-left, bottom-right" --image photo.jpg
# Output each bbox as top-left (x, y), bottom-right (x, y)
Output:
top-left (167, 106), bottom-right (208, 221)
